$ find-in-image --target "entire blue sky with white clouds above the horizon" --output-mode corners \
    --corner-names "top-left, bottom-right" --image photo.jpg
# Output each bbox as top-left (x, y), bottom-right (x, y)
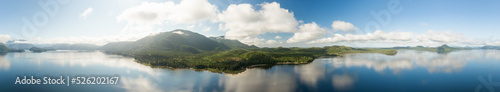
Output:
top-left (0, 0), bottom-right (500, 47)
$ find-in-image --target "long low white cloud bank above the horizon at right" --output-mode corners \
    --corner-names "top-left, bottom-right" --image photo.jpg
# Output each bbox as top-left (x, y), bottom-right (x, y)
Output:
top-left (308, 30), bottom-right (481, 45)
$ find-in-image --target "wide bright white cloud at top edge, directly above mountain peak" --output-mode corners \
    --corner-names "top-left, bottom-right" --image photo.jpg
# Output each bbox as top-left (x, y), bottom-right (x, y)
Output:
top-left (117, 0), bottom-right (217, 24)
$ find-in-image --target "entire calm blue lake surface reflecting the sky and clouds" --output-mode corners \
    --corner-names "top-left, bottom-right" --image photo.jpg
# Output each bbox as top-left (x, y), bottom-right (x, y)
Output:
top-left (0, 50), bottom-right (500, 92)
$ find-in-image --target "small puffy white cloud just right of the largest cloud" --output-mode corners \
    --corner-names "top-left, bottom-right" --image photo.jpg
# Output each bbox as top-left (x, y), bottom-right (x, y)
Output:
top-left (286, 22), bottom-right (325, 43)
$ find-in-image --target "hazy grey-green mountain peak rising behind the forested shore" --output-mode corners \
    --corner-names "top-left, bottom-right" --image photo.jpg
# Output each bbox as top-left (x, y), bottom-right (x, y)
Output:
top-left (100, 29), bottom-right (256, 54)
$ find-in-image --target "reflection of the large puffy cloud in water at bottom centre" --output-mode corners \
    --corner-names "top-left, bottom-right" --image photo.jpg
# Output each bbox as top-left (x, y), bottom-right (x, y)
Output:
top-left (221, 69), bottom-right (296, 92)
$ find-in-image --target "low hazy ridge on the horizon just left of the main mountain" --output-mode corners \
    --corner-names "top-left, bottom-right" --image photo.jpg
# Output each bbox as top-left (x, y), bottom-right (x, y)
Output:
top-left (48, 44), bottom-right (99, 50)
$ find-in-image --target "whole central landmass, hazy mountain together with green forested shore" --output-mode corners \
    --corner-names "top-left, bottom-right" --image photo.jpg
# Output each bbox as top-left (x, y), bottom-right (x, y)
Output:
top-left (100, 30), bottom-right (397, 73)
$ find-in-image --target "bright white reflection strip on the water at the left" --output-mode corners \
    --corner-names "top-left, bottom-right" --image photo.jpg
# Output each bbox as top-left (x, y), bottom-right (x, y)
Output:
top-left (10, 50), bottom-right (160, 79)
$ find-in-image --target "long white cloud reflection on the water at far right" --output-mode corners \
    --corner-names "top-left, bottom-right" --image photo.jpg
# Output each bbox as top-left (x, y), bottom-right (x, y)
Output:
top-left (326, 50), bottom-right (500, 74)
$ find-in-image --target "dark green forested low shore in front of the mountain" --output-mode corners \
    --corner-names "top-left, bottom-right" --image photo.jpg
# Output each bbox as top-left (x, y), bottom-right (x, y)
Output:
top-left (128, 46), bottom-right (397, 73)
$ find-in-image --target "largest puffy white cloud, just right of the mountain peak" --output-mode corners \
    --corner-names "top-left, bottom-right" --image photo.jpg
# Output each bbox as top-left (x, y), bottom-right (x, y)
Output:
top-left (218, 2), bottom-right (299, 44)
